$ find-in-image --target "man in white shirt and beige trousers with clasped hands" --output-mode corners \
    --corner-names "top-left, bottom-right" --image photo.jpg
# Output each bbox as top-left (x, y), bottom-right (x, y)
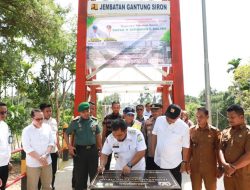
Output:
top-left (22, 109), bottom-right (55, 190)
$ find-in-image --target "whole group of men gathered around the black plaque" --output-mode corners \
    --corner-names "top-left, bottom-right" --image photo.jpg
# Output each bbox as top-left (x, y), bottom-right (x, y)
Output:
top-left (0, 101), bottom-right (250, 190)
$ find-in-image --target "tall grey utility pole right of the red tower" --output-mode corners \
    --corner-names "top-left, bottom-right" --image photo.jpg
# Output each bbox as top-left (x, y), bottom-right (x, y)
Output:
top-left (201, 0), bottom-right (212, 124)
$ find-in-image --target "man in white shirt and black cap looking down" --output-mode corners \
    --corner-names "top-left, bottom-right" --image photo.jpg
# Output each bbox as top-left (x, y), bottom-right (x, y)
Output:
top-left (151, 104), bottom-right (190, 189)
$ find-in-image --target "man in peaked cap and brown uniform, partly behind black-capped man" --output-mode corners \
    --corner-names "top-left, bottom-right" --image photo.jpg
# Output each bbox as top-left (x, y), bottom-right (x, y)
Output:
top-left (143, 104), bottom-right (162, 170)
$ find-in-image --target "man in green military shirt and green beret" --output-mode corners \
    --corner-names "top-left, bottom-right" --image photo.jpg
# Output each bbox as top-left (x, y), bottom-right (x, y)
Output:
top-left (64, 102), bottom-right (102, 190)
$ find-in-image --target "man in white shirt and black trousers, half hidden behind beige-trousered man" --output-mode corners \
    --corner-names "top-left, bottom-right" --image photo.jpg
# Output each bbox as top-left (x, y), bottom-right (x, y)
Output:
top-left (38, 103), bottom-right (61, 189)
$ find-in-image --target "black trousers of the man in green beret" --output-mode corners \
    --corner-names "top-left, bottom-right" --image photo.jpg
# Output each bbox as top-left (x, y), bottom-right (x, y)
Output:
top-left (74, 145), bottom-right (98, 190)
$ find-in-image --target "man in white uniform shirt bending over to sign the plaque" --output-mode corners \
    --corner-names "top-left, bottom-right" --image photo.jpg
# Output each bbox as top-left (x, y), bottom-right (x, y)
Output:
top-left (98, 119), bottom-right (147, 174)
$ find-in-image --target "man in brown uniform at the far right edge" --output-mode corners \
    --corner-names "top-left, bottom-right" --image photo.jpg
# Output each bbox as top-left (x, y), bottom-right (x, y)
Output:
top-left (220, 105), bottom-right (250, 190)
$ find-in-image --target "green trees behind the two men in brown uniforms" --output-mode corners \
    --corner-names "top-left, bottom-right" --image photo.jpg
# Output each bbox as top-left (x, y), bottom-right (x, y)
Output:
top-left (185, 58), bottom-right (250, 130)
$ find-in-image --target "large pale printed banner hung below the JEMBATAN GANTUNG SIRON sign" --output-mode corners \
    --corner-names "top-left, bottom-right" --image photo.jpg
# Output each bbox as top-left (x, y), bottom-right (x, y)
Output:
top-left (87, 15), bottom-right (171, 68)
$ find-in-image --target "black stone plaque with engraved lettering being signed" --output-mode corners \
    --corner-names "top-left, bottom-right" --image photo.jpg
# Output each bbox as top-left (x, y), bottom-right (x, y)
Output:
top-left (89, 170), bottom-right (181, 190)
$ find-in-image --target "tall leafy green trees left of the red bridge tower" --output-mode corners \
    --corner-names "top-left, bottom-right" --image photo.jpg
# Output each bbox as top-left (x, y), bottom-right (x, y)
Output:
top-left (0, 0), bottom-right (76, 137)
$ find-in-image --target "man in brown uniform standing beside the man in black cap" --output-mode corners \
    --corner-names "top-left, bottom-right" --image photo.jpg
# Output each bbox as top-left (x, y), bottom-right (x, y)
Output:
top-left (190, 107), bottom-right (222, 190)
